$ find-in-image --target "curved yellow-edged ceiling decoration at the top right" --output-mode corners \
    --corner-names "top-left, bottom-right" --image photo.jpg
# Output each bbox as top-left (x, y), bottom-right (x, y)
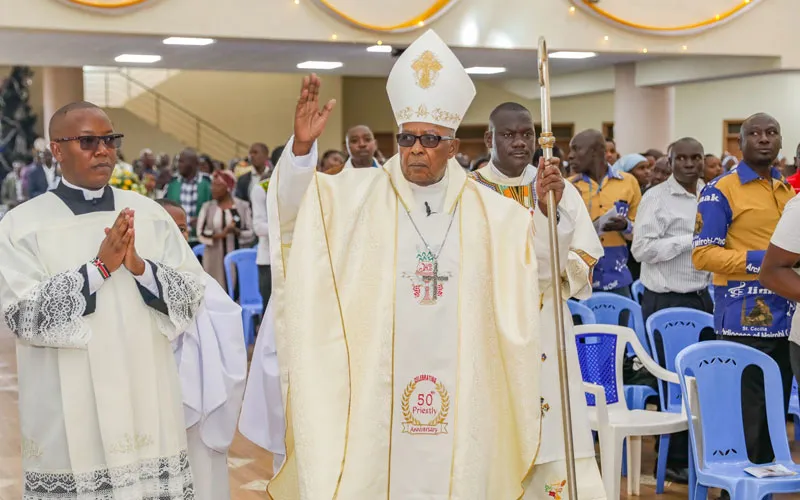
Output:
top-left (570, 0), bottom-right (762, 36)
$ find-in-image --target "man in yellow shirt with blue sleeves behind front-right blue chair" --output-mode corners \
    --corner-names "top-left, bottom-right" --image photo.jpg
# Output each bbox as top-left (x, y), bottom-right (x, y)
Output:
top-left (692, 113), bottom-right (794, 472)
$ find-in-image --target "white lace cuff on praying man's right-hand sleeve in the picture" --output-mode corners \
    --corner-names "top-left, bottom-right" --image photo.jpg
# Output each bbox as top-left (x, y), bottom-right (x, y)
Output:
top-left (155, 264), bottom-right (204, 334)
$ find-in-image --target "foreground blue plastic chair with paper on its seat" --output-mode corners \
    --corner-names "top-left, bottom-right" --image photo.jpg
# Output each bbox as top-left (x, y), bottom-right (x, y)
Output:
top-left (675, 340), bottom-right (800, 500)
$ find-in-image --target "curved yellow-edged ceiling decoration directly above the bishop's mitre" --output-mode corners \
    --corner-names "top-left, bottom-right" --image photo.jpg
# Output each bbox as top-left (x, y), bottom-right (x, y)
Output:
top-left (314, 0), bottom-right (457, 33)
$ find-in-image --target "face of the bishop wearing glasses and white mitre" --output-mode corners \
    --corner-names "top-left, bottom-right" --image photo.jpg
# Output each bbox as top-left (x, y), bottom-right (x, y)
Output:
top-left (397, 122), bottom-right (459, 186)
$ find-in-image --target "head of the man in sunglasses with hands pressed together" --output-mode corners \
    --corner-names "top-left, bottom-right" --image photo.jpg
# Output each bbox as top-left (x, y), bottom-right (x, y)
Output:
top-left (50, 108), bottom-right (119, 189)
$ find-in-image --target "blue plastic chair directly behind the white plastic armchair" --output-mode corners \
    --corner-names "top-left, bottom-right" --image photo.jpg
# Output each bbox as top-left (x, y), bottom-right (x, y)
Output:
top-left (583, 292), bottom-right (658, 410)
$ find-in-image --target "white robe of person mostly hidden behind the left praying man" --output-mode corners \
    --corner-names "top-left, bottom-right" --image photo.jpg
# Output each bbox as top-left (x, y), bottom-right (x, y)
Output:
top-left (173, 275), bottom-right (247, 500)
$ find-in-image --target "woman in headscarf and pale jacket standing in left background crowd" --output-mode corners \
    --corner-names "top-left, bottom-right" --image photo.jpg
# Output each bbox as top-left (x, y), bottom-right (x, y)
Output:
top-left (197, 170), bottom-right (254, 287)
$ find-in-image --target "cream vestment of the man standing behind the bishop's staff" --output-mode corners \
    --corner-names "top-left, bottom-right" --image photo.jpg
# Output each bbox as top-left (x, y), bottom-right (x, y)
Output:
top-left (472, 161), bottom-right (605, 500)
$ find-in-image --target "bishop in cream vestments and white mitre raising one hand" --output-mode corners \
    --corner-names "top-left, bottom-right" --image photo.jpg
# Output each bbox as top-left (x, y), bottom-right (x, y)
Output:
top-left (267, 31), bottom-right (542, 500)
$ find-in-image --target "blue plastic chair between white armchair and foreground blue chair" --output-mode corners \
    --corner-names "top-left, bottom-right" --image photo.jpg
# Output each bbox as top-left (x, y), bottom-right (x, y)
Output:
top-left (647, 307), bottom-right (714, 495)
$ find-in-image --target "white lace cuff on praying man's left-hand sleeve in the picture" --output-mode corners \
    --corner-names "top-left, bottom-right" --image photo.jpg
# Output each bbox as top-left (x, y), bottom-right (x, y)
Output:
top-left (4, 269), bottom-right (92, 347)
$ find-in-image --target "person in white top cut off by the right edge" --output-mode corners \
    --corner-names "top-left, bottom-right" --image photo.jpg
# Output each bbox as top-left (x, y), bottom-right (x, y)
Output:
top-left (759, 191), bottom-right (800, 390)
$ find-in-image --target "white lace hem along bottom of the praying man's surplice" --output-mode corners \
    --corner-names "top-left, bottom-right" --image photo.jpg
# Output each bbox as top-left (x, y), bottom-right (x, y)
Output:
top-left (22, 451), bottom-right (194, 500)
